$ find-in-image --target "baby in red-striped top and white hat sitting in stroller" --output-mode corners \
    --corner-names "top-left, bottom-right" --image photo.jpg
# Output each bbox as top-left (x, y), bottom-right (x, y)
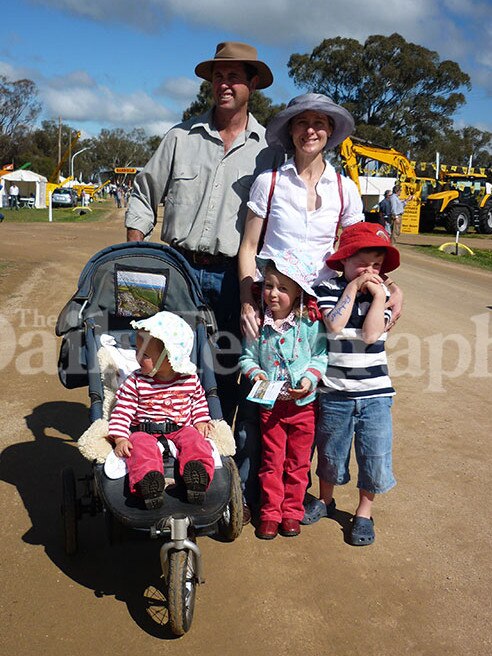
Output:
top-left (109, 312), bottom-right (214, 509)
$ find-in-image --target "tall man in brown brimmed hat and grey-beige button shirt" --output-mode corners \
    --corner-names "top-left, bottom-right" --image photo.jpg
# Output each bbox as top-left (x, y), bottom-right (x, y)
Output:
top-left (126, 41), bottom-right (281, 524)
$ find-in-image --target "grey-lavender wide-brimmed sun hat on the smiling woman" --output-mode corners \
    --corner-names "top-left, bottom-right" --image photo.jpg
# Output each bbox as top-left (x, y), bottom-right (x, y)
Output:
top-left (265, 93), bottom-right (355, 153)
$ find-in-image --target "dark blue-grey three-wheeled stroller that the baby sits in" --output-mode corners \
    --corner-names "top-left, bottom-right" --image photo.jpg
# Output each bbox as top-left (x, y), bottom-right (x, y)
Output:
top-left (56, 242), bottom-right (243, 635)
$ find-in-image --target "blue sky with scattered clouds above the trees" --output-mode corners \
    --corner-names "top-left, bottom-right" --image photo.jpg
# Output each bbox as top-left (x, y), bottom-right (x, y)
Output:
top-left (0, 0), bottom-right (492, 136)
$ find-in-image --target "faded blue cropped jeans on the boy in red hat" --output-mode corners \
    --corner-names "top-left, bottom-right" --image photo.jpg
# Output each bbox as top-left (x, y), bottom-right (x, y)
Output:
top-left (315, 394), bottom-right (396, 494)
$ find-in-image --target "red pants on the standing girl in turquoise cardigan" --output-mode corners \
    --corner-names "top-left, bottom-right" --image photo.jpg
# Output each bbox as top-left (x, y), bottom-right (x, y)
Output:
top-left (259, 401), bottom-right (316, 522)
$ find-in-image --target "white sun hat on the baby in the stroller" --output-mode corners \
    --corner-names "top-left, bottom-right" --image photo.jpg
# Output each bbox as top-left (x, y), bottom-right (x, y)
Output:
top-left (131, 312), bottom-right (196, 376)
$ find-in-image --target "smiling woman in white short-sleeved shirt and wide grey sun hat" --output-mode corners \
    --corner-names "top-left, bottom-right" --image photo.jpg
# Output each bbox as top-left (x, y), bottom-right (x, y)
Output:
top-left (239, 93), bottom-right (401, 338)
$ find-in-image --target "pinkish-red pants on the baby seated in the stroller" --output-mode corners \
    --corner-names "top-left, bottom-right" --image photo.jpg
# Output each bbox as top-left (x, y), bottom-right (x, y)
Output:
top-left (126, 426), bottom-right (214, 493)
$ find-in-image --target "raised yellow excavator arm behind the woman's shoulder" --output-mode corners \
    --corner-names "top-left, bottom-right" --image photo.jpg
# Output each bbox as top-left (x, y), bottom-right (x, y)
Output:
top-left (340, 137), bottom-right (424, 233)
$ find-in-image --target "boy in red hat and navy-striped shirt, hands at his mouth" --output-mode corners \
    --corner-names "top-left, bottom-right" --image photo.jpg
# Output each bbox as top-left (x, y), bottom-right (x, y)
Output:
top-left (315, 223), bottom-right (400, 546)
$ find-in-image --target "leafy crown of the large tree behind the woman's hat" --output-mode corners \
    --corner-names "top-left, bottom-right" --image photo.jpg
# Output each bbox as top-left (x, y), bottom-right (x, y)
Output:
top-left (288, 34), bottom-right (470, 158)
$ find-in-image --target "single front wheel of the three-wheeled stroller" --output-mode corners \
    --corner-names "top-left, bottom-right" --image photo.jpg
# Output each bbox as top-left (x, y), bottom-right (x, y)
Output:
top-left (167, 549), bottom-right (197, 636)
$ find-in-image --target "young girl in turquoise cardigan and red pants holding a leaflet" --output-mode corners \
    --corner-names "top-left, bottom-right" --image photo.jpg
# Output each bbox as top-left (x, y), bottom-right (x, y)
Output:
top-left (240, 251), bottom-right (327, 540)
